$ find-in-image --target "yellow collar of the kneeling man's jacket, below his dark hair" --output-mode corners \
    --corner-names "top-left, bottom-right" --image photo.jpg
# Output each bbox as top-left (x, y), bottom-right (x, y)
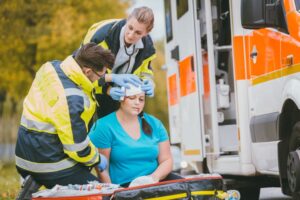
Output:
top-left (61, 56), bottom-right (94, 94)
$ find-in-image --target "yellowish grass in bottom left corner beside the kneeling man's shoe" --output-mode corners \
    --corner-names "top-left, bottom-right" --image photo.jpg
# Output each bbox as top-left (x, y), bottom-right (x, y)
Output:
top-left (0, 161), bottom-right (20, 200)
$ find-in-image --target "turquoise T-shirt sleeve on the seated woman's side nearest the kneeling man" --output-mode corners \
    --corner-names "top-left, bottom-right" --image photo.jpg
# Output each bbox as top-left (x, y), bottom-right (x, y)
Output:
top-left (89, 119), bottom-right (112, 149)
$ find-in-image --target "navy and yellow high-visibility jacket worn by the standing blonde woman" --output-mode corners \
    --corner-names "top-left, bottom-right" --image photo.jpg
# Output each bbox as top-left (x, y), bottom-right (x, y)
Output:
top-left (83, 19), bottom-right (156, 94)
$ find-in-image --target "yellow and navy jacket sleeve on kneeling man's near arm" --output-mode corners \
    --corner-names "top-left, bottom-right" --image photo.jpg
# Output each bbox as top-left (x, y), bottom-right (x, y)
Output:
top-left (52, 88), bottom-right (99, 166)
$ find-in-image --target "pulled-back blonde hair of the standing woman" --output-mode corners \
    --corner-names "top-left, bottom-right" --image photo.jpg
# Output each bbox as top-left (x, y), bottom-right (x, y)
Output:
top-left (127, 6), bottom-right (154, 33)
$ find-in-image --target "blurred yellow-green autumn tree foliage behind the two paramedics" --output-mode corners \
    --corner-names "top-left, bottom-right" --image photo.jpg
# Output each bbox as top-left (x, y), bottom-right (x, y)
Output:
top-left (0, 0), bottom-right (129, 101)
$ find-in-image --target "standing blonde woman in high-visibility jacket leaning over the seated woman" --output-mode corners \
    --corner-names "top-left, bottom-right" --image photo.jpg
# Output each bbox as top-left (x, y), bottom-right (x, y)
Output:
top-left (83, 7), bottom-right (156, 117)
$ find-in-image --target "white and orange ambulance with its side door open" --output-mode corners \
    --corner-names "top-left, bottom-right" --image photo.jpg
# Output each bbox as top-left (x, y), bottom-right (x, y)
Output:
top-left (164, 0), bottom-right (300, 200)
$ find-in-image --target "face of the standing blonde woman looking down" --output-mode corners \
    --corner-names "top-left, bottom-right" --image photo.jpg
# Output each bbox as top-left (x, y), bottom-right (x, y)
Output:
top-left (124, 17), bottom-right (148, 45)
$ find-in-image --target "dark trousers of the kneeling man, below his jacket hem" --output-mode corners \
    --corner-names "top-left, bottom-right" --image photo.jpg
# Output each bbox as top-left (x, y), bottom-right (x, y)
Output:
top-left (17, 166), bottom-right (99, 189)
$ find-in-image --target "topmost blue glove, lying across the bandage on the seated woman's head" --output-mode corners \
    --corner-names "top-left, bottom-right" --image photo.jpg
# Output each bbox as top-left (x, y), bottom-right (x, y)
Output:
top-left (111, 74), bottom-right (142, 89)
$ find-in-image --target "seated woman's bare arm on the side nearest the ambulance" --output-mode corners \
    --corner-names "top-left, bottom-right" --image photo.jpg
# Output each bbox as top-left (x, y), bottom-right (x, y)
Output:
top-left (151, 140), bottom-right (173, 181)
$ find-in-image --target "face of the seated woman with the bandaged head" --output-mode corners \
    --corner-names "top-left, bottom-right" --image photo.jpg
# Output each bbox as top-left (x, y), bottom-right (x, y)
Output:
top-left (120, 93), bottom-right (145, 115)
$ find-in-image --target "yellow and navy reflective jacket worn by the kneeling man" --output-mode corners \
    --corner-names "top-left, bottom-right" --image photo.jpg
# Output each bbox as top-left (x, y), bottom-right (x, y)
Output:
top-left (16, 56), bottom-right (99, 179)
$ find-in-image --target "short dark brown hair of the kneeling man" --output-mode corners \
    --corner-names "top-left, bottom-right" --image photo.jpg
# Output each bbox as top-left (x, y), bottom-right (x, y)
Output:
top-left (75, 42), bottom-right (115, 71)
